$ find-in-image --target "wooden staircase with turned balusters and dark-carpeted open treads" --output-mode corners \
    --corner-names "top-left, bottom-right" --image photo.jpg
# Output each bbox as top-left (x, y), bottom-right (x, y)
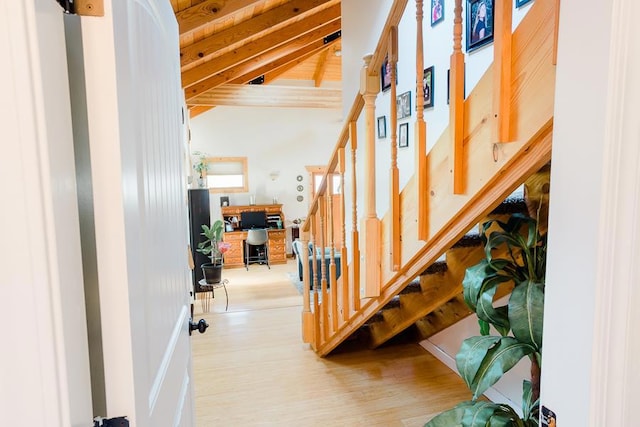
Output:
top-left (301, 0), bottom-right (557, 356)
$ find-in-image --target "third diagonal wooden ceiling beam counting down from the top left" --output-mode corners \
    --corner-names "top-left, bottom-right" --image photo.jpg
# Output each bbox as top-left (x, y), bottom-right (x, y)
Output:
top-left (182, 5), bottom-right (340, 87)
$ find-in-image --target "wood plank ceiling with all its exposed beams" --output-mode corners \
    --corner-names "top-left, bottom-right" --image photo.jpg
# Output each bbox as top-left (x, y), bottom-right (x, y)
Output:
top-left (171, 0), bottom-right (342, 117)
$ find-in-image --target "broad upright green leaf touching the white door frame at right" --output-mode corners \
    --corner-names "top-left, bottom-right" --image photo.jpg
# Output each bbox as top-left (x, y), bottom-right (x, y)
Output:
top-left (509, 280), bottom-right (544, 351)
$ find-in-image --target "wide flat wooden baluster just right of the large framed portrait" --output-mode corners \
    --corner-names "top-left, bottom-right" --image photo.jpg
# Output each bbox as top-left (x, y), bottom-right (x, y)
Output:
top-left (491, 0), bottom-right (513, 143)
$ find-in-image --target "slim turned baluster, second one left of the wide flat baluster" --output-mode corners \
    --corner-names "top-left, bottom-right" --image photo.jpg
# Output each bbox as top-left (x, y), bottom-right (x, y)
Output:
top-left (416, 0), bottom-right (433, 239)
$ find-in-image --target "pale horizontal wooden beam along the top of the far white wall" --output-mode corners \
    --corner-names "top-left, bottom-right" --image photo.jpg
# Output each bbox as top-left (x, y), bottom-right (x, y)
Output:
top-left (189, 85), bottom-right (342, 109)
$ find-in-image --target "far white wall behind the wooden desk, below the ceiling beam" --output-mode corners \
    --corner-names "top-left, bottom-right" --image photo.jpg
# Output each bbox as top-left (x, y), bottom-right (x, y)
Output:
top-left (190, 107), bottom-right (342, 226)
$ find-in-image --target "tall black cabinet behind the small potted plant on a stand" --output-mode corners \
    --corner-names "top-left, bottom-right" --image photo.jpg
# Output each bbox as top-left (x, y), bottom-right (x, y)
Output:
top-left (189, 188), bottom-right (211, 292)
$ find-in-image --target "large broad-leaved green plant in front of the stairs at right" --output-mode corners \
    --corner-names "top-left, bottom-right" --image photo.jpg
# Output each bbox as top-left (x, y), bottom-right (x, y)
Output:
top-left (425, 214), bottom-right (547, 427)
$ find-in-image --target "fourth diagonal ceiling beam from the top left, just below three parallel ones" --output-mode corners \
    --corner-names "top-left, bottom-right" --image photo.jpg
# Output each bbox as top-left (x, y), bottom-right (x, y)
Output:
top-left (183, 20), bottom-right (340, 101)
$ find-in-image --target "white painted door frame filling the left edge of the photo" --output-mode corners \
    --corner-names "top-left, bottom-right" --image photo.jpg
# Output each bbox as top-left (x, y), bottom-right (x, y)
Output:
top-left (0, 0), bottom-right (92, 427)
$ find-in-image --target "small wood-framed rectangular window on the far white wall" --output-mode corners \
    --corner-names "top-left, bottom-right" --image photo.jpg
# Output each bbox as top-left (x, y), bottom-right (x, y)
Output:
top-left (207, 157), bottom-right (249, 193)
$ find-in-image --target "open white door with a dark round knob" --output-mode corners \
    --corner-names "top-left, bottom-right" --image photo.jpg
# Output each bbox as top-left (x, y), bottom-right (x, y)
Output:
top-left (73, 0), bottom-right (194, 426)
